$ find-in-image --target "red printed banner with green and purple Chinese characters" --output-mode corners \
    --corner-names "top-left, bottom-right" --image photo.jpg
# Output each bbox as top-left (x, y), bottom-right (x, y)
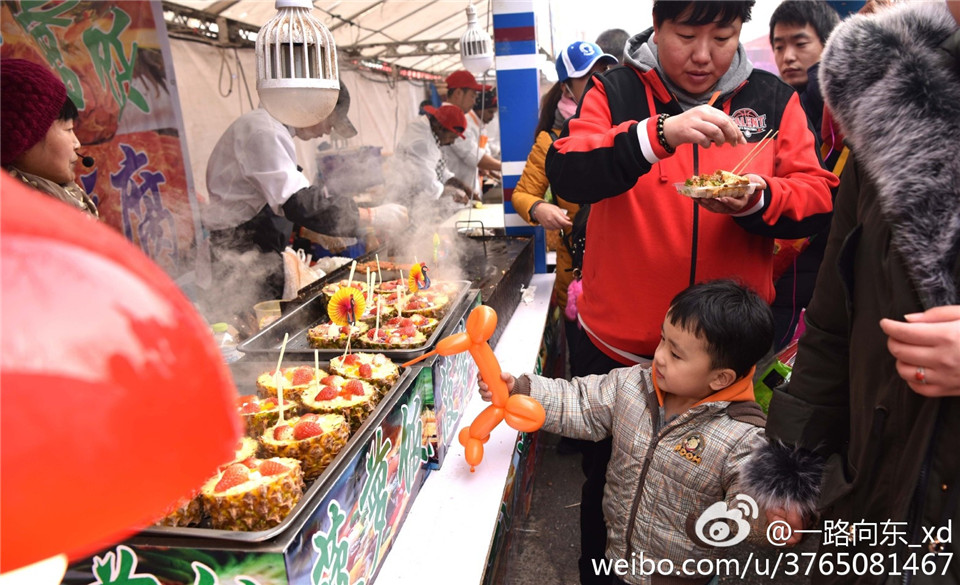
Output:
top-left (0, 0), bottom-right (198, 278)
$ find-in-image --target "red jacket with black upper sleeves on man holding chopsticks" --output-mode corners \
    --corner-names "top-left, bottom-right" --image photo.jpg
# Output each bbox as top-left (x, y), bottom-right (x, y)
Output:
top-left (546, 67), bottom-right (838, 364)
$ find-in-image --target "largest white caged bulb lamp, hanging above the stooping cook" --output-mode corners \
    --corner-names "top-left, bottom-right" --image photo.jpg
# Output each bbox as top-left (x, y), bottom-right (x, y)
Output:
top-left (257, 0), bottom-right (340, 128)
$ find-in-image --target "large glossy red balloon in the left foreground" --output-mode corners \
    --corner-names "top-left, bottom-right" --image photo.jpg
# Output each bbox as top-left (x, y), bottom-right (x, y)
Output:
top-left (0, 172), bottom-right (242, 572)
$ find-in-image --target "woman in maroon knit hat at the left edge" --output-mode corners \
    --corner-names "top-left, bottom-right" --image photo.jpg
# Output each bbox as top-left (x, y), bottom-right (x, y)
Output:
top-left (0, 59), bottom-right (98, 217)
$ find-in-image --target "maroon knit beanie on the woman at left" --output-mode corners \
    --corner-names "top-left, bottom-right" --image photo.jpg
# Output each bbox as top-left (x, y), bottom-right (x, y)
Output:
top-left (0, 59), bottom-right (67, 166)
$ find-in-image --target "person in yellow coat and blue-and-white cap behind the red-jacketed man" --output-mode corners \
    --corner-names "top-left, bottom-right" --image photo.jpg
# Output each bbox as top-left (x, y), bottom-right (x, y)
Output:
top-left (512, 42), bottom-right (617, 375)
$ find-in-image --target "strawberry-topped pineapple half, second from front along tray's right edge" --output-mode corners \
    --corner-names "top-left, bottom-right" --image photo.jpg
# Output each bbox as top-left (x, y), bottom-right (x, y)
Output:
top-left (260, 412), bottom-right (350, 480)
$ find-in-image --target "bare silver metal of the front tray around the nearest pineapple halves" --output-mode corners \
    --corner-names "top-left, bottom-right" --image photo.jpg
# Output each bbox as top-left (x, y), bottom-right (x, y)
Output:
top-left (139, 358), bottom-right (420, 543)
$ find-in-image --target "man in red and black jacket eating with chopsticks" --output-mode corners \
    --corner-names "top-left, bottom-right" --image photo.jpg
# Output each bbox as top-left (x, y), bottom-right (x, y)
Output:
top-left (546, 0), bottom-right (837, 582)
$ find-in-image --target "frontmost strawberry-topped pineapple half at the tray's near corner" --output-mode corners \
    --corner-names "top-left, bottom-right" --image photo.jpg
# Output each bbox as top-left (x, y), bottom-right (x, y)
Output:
top-left (200, 457), bottom-right (303, 530)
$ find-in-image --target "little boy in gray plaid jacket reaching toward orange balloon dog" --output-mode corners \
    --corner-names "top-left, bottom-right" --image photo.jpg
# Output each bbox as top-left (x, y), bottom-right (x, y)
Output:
top-left (480, 280), bottom-right (808, 584)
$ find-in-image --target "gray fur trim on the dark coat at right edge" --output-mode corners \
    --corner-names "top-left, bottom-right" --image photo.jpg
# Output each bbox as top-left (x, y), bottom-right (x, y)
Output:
top-left (820, 2), bottom-right (960, 308)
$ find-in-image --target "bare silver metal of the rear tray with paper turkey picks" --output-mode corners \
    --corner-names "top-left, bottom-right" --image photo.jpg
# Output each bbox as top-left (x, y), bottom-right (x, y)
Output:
top-left (237, 280), bottom-right (470, 362)
